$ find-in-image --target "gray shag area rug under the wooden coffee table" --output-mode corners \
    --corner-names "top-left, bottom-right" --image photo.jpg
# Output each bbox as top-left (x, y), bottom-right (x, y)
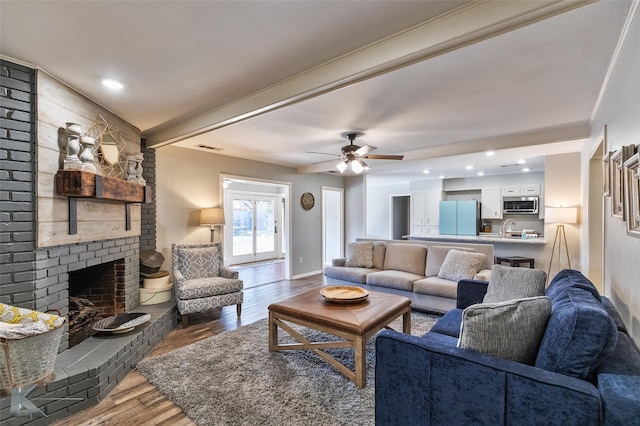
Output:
top-left (137, 312), bottom-right (438, 426)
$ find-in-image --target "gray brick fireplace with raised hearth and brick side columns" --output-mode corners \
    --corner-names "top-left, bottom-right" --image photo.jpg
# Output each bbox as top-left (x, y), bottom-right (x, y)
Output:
top-left (0, 59), bottom-right (177, 425)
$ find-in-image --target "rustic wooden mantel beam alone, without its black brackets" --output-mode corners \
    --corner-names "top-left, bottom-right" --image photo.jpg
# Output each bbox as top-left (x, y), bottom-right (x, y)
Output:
top-left (56, 170), bottom-right (148, 203)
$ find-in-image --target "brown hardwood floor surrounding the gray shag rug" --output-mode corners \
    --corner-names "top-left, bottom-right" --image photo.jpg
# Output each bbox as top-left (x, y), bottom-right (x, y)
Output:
top-left (53, 274), bottom-right (324, 426)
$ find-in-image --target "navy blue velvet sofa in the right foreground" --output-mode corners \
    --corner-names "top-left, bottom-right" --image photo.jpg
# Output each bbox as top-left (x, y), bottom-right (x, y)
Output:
top-left (375, 270), bottom-right (640, 426)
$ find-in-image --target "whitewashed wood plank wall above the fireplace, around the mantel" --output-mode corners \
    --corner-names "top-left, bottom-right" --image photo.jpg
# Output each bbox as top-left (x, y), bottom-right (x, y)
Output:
top-left (36, 70), bottom-right (141, 247)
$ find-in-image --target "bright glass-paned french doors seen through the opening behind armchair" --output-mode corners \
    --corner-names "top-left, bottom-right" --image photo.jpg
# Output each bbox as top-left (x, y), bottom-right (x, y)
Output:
top-left (225, 194), bottom-right (279, 265)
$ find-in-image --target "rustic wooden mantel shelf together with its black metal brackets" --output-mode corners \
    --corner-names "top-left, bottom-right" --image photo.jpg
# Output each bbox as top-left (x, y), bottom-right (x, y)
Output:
top-left (56, 170), bottom-right (152, 235)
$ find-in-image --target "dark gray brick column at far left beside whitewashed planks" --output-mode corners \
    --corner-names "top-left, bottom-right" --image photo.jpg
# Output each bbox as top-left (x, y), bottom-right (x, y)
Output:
top-left (0, 60), bottom-right (36, 309)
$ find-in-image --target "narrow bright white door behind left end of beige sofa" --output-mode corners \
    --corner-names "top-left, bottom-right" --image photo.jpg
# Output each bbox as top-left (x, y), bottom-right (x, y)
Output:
top-left (322, 187), bottom-right (344, 265)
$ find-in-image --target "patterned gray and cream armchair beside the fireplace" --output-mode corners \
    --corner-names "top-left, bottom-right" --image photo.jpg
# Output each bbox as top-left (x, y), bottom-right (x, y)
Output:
top-left (171, 243), bottom-right (243, 328)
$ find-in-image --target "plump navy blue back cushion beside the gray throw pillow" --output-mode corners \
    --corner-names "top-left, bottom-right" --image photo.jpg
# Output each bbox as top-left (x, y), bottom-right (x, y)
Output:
top-left (535, 287), bottom-right (618, 379)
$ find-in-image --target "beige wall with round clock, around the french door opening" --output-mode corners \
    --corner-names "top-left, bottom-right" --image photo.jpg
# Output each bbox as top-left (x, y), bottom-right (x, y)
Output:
top-left (156, 146), bottom-right (343, 277)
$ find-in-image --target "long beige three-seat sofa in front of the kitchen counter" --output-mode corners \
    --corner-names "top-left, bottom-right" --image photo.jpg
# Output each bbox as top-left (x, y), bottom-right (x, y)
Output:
top-left (324, 239), bottom-right (494, 313)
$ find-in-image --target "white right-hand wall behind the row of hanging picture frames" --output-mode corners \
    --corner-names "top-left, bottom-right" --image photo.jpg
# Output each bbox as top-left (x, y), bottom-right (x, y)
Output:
top-left (581, 2), bottom-right (640, 345)
